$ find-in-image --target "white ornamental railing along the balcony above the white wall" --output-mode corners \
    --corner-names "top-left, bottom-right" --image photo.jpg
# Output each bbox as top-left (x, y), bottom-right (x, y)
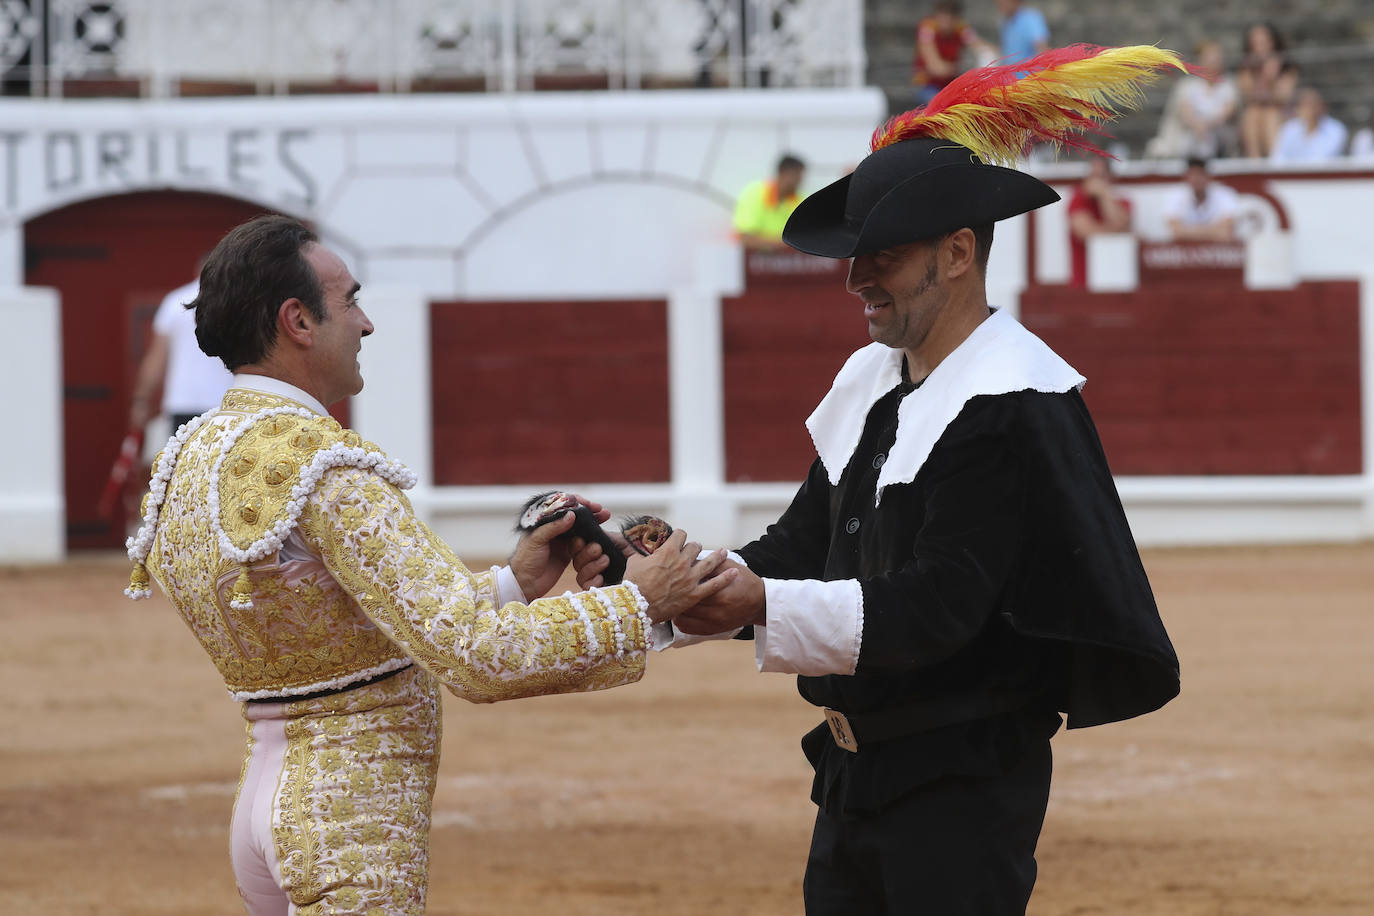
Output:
top-left (0, 0), bottom-right (864, 96)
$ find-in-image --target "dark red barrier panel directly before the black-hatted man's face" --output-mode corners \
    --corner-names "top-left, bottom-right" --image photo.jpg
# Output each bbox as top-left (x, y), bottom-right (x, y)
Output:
top-left (721, 253), bottom-right (871, 482)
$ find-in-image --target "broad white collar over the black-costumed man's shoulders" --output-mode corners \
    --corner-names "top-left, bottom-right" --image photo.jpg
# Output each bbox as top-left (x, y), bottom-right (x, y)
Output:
top-left (807, 309), bottom-right (1087, 505)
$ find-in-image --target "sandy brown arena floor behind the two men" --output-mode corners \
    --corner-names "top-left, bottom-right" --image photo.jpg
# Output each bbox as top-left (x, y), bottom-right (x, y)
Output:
top-left (0, 545), bottom-right (1374, 916)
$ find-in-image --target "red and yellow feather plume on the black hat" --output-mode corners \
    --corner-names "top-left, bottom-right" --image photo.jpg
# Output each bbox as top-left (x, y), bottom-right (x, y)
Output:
top-left (870, 44), bottom-right (1189, 165)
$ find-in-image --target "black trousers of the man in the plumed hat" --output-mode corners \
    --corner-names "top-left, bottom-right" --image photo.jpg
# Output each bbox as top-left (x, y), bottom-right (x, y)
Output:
top-left (802, 740), bottom-right (1051, 916)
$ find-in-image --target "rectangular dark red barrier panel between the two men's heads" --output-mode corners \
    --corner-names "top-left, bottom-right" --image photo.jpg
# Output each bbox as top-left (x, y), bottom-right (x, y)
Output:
top-left (430, 301), bottom-right (669, 485)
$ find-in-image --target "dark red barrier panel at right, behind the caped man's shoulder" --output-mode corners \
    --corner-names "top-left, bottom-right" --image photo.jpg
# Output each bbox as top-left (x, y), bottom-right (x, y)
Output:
top-left (1021, 282), bottom-right (1360, 474)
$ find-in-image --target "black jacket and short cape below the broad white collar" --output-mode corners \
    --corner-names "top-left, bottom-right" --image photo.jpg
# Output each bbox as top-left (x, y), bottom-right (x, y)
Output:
top-left (739, 383), bottom-right (1179, 814)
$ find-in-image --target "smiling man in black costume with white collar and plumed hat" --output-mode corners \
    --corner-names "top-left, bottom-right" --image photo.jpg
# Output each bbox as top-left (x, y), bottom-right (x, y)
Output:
top-left (576, 48), bottom-right (1179, 916)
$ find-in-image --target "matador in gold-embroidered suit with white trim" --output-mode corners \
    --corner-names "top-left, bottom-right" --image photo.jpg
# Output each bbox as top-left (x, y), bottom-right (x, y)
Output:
top-left (128, 211), bottom-right (732, 916)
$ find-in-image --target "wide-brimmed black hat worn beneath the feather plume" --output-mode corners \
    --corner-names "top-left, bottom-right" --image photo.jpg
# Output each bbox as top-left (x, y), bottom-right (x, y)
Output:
top-left (782, 137), bottom-right (1059, 258)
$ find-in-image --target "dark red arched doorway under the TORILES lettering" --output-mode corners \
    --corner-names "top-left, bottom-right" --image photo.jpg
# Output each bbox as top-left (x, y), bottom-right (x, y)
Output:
top-left (23, 191), bottom-right (276, 549)
